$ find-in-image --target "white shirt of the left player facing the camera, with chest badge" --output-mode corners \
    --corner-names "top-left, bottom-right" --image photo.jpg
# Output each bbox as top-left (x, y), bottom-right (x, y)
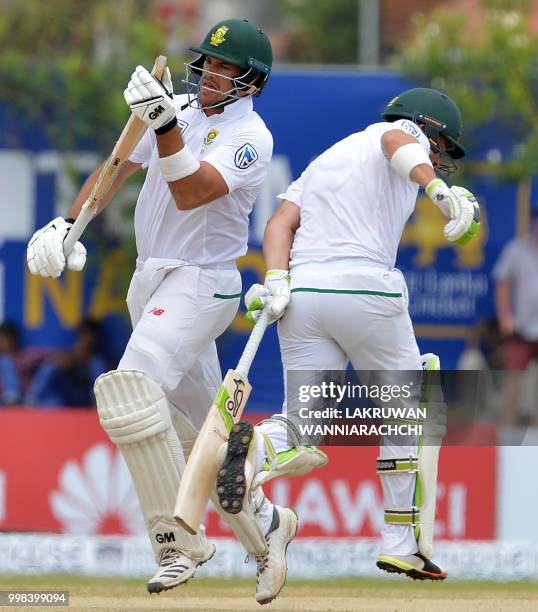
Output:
top-left (129, 95), bottom-right (273, 265)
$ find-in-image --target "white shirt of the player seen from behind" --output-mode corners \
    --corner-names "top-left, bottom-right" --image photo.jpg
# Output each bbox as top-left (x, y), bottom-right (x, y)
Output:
top-left (278, 120), bottom-right (430, 268)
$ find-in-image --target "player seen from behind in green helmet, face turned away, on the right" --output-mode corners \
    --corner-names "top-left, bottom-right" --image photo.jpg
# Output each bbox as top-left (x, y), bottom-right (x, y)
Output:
top-left (218, 88), bottom-right (480, 580)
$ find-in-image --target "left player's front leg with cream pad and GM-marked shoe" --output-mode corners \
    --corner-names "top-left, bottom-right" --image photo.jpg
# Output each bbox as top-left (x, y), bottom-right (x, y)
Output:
top-left (96, 267), bottom-right (240, 592)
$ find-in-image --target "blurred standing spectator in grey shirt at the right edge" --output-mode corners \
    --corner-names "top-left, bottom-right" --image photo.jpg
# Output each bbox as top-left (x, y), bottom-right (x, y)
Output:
top-left (493, 208), bottom-right (538, 425)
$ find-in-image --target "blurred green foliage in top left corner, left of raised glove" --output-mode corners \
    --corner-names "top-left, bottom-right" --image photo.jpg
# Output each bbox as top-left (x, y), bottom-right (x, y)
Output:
top-left (0, 0), bottom-right (168, 154)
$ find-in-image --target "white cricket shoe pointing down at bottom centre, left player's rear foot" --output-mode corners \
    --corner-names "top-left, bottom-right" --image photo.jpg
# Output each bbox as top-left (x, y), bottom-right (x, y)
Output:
top-left (256, 506), bottom-right (298, 605)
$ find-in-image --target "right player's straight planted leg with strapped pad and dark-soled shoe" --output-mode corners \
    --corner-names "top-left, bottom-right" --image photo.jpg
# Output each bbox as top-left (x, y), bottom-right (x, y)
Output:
top-left (331, 282), bottom-right (446, 580)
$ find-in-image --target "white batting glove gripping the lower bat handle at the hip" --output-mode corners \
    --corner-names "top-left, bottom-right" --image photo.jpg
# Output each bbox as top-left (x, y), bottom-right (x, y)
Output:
top-left (245, 270), bottom-right (290, 323)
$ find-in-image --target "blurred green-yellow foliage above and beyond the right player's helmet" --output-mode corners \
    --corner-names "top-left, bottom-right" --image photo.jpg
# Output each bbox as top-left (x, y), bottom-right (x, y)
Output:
top-left (396, 0), bottom-right (538, 179)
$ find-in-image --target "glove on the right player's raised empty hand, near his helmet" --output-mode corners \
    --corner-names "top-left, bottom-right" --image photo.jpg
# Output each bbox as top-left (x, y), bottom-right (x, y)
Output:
top-left (426, 178), bottom-right (480, 246)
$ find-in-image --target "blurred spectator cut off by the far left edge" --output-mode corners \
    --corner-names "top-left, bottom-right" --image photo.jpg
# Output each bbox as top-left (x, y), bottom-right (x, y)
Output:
top-left (0, 321), bottom-right (46, 406)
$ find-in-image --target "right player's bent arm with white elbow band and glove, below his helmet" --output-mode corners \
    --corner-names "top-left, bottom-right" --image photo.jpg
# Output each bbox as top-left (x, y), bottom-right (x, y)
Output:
top-left (381, 121), bottom-right (480, 245)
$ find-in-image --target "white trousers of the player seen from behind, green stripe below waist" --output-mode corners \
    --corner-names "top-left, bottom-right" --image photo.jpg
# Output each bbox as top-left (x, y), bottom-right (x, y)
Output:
top-left (262, 260), bottom-right (420, 555)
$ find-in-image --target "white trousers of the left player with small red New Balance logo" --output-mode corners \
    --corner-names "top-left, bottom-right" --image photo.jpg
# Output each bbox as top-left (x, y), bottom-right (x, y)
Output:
top-left (118, 259), bottom-right (241, 431)
